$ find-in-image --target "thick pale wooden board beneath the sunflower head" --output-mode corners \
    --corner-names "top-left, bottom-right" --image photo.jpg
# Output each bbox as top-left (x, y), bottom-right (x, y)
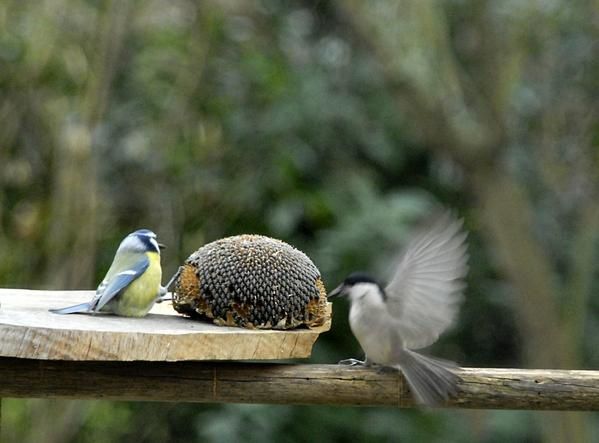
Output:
top-left (0, 289), bottom-right (331, 361)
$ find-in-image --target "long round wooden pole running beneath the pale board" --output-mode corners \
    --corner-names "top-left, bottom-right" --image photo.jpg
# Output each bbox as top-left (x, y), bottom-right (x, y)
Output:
top-left (0, 358), bottom-right (599, 411)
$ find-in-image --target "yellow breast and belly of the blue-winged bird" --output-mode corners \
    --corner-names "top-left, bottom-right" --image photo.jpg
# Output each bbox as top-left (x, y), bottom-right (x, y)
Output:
top-left (112, 252), bottom-right (162, 317)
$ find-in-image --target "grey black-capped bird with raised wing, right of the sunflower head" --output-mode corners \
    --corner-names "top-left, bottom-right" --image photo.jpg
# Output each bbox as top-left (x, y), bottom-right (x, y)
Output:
top-left (329, 212), bottom-right (468, 406)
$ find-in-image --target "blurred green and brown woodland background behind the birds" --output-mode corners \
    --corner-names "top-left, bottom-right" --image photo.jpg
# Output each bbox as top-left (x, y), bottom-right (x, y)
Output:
top-left (0, 0), bottom-right (599, 443)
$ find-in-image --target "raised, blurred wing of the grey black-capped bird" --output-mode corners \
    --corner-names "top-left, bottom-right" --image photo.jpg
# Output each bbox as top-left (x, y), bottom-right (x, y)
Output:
top-left (385, 212), bottom-right (468, 349)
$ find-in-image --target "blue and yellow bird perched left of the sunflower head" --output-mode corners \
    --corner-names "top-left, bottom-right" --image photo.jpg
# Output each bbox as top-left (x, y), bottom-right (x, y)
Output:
top-left (50, 229), bottom-right (166, 317)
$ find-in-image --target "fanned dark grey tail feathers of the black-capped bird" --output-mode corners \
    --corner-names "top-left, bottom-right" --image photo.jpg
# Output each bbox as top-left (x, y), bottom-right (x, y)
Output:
top-left (399, 349), bottom-right (460, 406)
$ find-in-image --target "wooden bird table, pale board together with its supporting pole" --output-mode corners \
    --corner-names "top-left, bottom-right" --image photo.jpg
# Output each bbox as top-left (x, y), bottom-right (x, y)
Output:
top-left (0, 289), bottom-right (599, 410)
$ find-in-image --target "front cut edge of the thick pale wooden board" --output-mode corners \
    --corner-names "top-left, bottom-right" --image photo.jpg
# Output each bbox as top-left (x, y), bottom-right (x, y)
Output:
top-left (0, 324), bottom-right (320, 362)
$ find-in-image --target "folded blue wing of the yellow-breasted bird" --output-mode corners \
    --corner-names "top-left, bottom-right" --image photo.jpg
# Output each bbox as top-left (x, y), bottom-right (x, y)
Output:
top-left (93, 254), bottom-right (150, 312)
